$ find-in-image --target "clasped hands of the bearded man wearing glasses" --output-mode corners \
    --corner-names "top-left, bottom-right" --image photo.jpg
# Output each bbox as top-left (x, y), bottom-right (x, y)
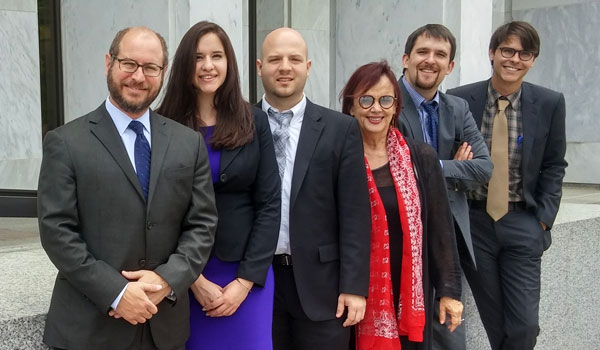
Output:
top-left (108, 270), bottom-right (171, 325)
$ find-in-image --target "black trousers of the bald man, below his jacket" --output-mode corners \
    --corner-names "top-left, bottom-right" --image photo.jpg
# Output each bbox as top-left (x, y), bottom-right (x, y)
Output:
top-left (273, 264), bottom-right (350, 350)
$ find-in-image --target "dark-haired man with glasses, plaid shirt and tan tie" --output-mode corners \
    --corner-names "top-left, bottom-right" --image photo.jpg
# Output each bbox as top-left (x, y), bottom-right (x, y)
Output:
top-left (448, 21), bottom-right (567, 350)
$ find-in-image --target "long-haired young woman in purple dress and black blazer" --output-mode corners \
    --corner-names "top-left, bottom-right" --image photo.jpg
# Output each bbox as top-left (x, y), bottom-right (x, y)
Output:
top-left (157, 21), bottom-right (280, 350)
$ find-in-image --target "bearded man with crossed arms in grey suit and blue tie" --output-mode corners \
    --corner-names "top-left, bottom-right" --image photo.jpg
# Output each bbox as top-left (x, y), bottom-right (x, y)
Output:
top-left (398, 24), bottom-right (493, 350)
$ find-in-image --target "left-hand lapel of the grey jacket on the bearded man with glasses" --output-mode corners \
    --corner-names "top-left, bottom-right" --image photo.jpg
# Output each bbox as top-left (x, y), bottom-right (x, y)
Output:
top-left (90, 103), bottom-right (144, 199)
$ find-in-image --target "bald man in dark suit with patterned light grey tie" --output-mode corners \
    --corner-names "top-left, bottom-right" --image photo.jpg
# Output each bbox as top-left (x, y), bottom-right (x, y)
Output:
top-left (256, 28), bottom-right (371, 350)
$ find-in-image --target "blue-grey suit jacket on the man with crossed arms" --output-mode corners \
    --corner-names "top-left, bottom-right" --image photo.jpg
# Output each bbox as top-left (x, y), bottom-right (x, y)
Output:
top-left (398, 80), bottom-right (493, 264)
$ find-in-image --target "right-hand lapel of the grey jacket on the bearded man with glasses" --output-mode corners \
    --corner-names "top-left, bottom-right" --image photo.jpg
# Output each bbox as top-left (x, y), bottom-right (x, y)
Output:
top-left (147, 110), bottom-right (171, 203)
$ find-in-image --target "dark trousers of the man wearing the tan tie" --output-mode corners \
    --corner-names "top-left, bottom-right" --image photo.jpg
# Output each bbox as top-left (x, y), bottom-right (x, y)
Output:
top-left (463, 207), bottom-right (546, 350)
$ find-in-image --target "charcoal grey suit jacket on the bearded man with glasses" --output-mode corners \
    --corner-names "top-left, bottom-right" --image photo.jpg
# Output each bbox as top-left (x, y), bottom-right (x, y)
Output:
top-left (38, 103), bottom-right (217, 349)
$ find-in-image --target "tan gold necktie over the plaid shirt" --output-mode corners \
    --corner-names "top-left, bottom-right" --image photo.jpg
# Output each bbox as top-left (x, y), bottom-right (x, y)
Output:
top-left (486, 99), bottom-right (508, 221)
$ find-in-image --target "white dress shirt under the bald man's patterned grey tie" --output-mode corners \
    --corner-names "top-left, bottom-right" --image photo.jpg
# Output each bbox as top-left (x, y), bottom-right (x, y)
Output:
top-left (262, 95), bottom-right (306, 254)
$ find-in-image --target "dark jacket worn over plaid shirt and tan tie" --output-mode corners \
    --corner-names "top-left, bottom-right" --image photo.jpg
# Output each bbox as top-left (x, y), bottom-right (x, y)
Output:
top-left (448, 80), bottom-right (567, 231)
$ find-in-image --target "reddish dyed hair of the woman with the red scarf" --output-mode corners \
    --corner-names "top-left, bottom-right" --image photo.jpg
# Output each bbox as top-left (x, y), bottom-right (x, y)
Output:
top-left (340, 60), bottom-right (402, 127)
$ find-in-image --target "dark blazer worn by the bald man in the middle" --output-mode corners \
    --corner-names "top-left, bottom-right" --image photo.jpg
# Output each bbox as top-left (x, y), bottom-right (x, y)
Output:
top-left (259, 99), bottom-right (371, 321)
